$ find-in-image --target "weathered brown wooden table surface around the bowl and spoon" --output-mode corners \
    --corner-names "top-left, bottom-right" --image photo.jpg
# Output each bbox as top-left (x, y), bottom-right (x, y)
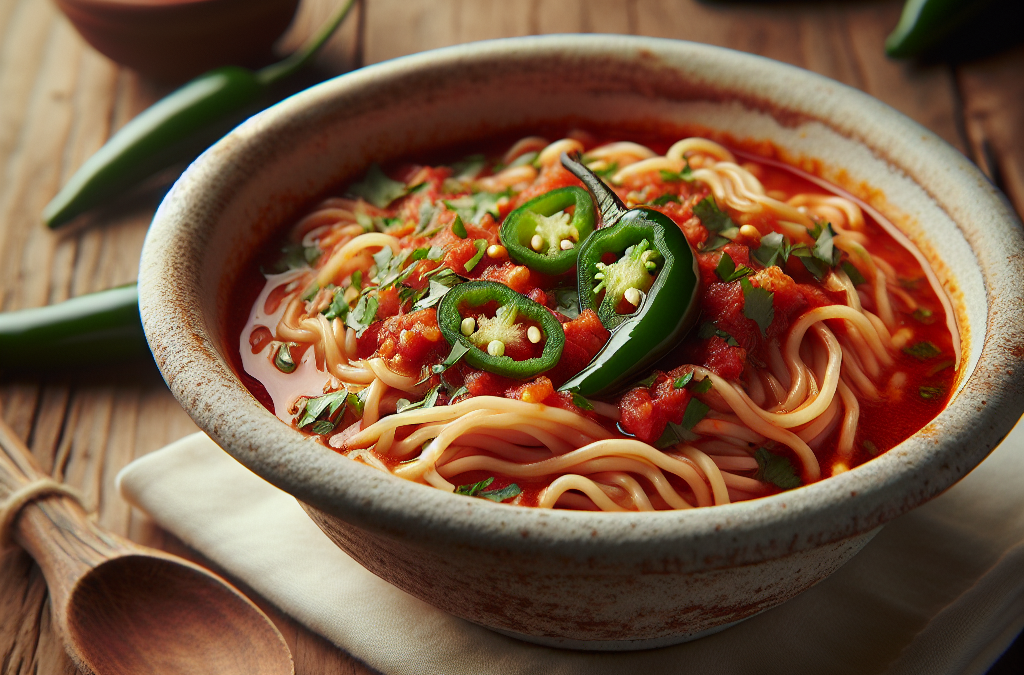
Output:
top-left (0, 0), bottom-right (1024, 675)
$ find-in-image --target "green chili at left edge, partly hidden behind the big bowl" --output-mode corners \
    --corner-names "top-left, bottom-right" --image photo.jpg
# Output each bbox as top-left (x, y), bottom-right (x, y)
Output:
top-left (0, 284), bottom-right (150, 370)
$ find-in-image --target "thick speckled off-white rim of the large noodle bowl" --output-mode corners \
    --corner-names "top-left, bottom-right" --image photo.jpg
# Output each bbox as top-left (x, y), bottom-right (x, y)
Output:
top-left (139, 35), bottom-right (1024, 569)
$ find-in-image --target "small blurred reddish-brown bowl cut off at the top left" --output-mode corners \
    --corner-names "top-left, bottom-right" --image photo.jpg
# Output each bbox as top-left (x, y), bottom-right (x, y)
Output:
top-left (56, 0), bottom-right (299, 82)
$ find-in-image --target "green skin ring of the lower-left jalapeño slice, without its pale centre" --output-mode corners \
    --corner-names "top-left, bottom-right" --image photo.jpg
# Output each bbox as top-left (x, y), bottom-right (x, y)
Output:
top-left (437, 281), bottom-right (565, 380)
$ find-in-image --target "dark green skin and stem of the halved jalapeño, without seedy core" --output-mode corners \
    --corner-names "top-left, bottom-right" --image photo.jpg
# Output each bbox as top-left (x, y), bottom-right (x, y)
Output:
top-left (561, 154), bottom-right (700, 396)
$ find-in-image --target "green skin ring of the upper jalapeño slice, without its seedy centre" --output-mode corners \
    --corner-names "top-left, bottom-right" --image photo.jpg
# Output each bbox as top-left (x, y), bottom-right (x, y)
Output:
top-left (499, 186), bottom-right (594, 275)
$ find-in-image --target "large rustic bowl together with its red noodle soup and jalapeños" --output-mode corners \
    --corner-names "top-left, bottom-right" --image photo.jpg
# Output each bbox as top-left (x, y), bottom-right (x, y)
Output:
top-left (139, 36), bottom-right (1024, 649)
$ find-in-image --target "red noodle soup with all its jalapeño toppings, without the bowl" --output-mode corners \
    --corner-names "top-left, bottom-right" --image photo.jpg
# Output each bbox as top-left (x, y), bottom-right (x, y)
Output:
top-left (240, 131), bottom-right (958, 511)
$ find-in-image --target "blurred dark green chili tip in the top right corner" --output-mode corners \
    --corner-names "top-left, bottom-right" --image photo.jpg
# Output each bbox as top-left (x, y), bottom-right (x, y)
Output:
top-left (886, 0), bottom-right (994, 58)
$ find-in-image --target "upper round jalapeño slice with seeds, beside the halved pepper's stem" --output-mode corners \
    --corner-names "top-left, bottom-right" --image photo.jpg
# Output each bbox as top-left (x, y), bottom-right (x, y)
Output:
top-left (500, 186), bottom-right (594, 275)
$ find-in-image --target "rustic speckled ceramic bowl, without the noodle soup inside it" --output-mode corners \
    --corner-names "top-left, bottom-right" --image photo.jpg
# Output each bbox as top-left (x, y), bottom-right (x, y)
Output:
top-left (139, 36), bottom-right (1024, 649)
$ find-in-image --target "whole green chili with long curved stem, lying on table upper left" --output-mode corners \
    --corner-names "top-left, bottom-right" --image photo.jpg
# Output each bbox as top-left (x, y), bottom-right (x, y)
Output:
top-left (43, 0), bottom-right (354, 227)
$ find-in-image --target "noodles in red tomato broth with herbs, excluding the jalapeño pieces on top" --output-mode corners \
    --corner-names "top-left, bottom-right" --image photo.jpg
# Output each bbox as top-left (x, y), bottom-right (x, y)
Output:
top-left (240, 132), bottom-right (958, 511)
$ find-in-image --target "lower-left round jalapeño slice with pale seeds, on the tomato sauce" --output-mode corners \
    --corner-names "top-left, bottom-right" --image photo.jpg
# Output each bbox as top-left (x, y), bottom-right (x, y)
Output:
top-left (437, 281), bottom-right (565, 380)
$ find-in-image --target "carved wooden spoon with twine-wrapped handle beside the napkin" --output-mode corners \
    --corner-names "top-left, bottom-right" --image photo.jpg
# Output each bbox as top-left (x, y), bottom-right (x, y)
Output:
top-left (0, 421), bottom-right (295, 675)
